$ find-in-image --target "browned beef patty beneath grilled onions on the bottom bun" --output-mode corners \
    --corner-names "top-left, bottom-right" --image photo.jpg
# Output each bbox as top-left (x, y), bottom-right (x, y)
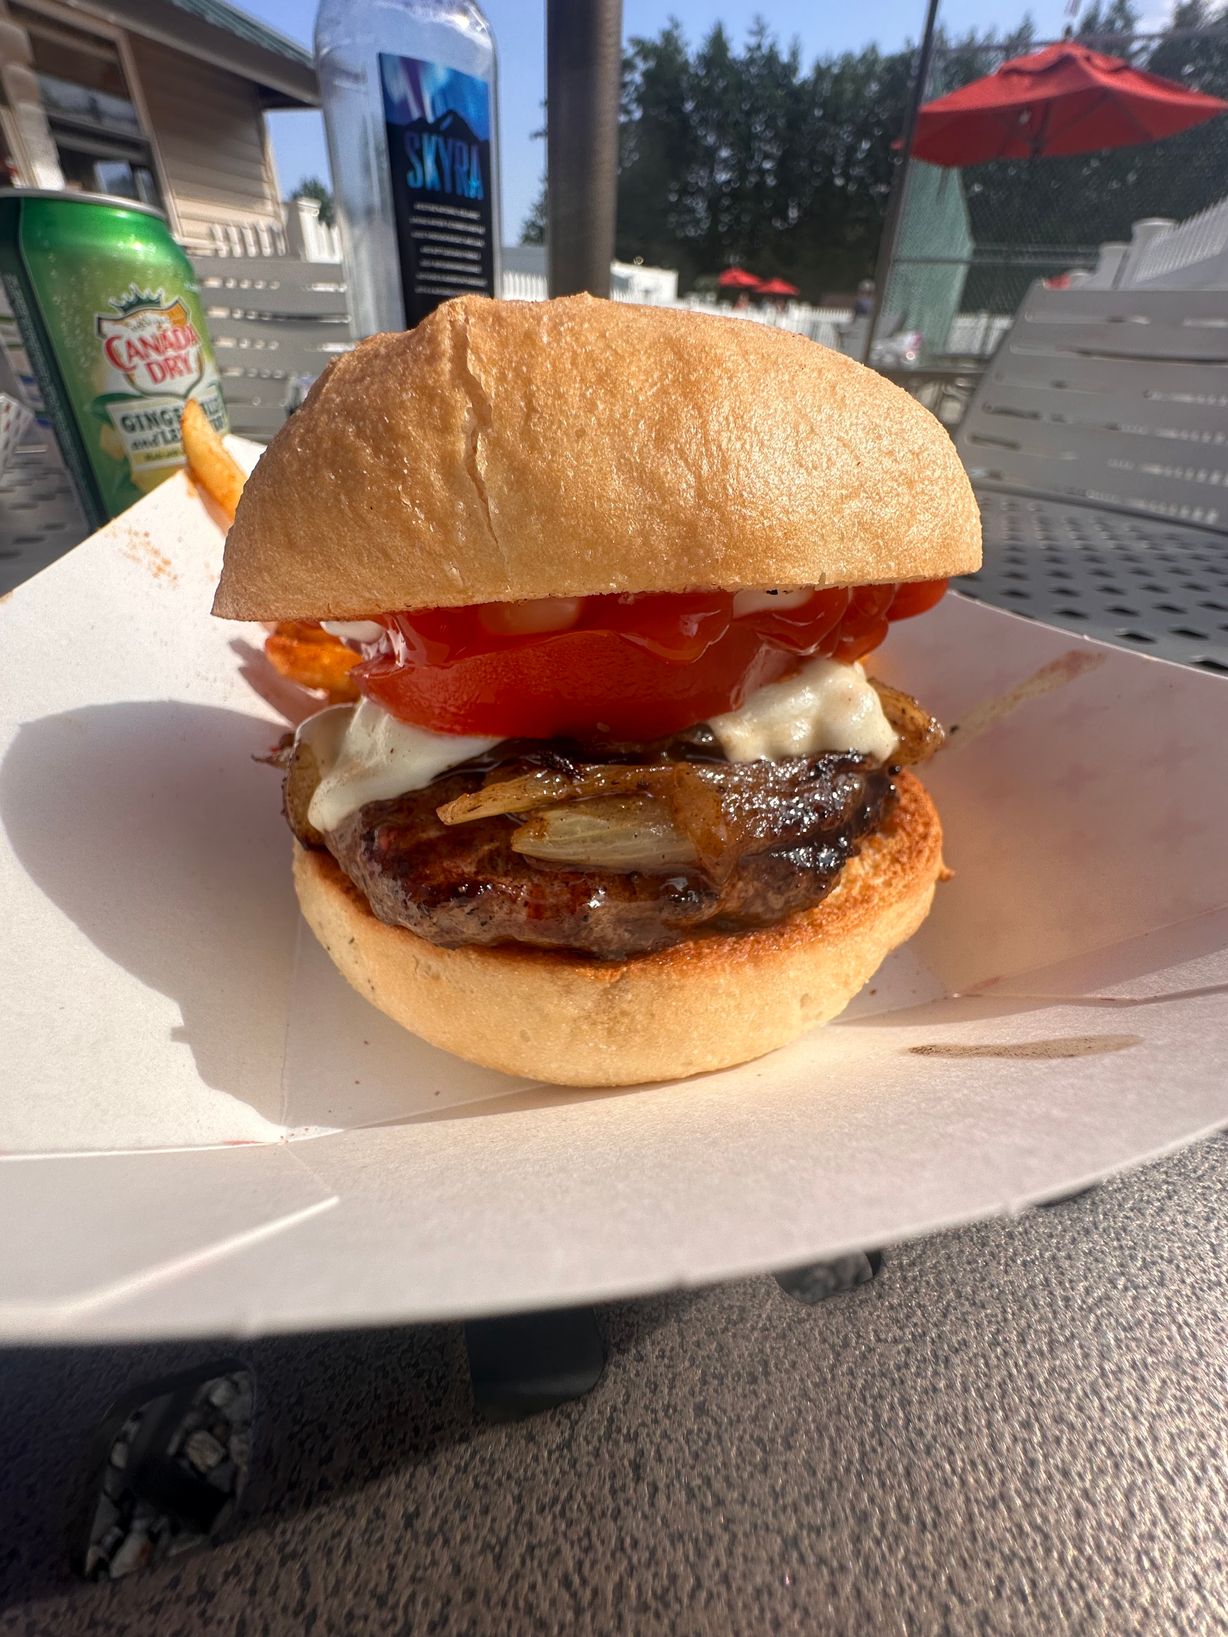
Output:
top-left (295, 730), bottom-right (894, 961)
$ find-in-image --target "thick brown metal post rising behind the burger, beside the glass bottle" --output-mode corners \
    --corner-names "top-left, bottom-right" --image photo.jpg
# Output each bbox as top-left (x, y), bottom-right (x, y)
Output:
top-left (545, 0), bottom-right (622, 296)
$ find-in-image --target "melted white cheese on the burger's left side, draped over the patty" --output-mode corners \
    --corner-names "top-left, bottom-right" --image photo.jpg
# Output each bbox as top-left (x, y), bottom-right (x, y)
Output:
top-left (296, 699), bottom-right (499, 830)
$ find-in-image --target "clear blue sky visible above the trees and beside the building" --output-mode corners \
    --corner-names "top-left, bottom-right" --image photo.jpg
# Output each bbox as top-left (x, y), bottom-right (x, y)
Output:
top-left (255, 0), bottom-right (1068, 242)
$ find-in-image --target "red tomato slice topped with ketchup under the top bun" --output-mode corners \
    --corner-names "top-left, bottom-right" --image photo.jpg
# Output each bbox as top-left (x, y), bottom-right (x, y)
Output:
top-left (354, 586), bottom-right (945, 742)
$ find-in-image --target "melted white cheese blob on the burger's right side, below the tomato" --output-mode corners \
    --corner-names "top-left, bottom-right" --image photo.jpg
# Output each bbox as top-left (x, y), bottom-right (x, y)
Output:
top-left (707, 660), bottom-right (897, 761)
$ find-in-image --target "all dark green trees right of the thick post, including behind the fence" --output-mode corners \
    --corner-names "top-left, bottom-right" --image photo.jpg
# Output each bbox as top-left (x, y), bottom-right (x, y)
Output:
top-left (617, 9), bottom-right (1228, 300)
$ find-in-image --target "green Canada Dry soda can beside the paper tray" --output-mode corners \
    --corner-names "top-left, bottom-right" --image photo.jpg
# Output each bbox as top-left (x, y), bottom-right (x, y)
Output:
top-left (0, 188), bottom-right (229, 527)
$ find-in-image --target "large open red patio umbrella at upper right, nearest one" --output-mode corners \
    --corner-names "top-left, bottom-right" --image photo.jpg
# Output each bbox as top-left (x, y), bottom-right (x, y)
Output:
top-left (912, 41), bottom-right (1228, 165)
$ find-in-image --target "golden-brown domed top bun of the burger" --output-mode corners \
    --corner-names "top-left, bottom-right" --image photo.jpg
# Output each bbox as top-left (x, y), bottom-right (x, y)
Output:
top-left (213, 296), bottom-right (981, 619)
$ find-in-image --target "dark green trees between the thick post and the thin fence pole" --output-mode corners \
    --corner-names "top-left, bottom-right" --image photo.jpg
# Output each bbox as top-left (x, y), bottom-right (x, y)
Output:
top-left (617, 20), bottom-right (910, 295)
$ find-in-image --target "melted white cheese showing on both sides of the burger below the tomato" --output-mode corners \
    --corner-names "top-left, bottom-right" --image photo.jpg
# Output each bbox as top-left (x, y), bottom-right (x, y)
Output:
top-left (298, 660), bottom-right (896, 830)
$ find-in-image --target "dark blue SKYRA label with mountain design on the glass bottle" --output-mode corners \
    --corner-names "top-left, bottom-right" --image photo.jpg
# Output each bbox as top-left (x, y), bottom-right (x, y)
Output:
top-left (380, 51), bottom-right (494, 327)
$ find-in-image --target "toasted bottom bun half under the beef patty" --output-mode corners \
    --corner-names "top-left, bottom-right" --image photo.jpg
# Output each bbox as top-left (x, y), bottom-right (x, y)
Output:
top-left (295, 774), bottom-right (943, 1085)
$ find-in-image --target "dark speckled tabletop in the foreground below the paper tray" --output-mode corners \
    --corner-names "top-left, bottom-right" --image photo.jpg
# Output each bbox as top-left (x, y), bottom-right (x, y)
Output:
top-left (0, 1138), bottom-right (1228, 1637)
